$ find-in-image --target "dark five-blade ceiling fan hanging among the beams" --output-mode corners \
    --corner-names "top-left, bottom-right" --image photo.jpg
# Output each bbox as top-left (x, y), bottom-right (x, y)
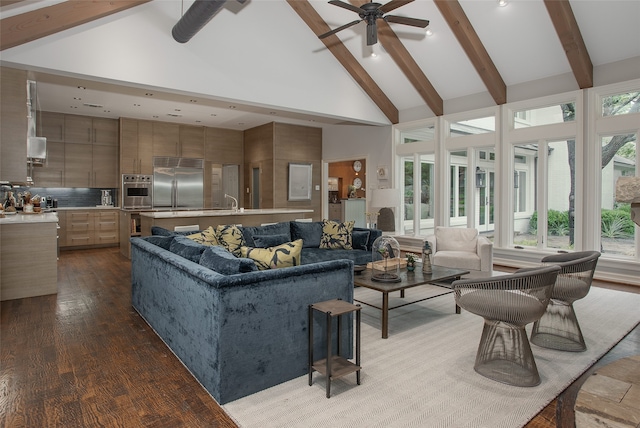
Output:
top-left (318, 0), bottom-right (429, 46)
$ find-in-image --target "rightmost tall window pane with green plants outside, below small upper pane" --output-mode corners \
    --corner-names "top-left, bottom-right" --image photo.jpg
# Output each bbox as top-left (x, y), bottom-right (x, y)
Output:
top-left (601, 134), bottom-right (638, 257)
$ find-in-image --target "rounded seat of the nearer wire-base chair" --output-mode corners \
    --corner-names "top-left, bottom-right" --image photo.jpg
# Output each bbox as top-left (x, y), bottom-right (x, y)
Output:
top-left (457, 290), bottom-right (546, 325)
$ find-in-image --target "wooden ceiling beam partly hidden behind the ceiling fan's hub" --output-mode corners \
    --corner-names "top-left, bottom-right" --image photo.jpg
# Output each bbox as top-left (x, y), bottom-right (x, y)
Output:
top-left (350, 0), bottom-right (444, 116)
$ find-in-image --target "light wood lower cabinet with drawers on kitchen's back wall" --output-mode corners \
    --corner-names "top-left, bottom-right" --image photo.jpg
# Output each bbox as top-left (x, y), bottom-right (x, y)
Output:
top-left (60, 209), bottom-right (120, 247)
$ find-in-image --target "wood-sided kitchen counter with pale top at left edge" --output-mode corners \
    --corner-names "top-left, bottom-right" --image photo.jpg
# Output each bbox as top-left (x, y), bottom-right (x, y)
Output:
top-left (0, 213), bottom-right (58, 300)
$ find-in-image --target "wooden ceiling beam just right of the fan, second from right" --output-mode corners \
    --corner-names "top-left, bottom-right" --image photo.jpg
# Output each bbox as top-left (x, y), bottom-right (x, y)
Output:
top-left (433, 0), bottom-right (507, 105)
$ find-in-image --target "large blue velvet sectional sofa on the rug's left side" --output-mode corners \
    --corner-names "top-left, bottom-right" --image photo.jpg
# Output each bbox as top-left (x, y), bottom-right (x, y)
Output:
top-left (131, 222), bottom-right (381, 404)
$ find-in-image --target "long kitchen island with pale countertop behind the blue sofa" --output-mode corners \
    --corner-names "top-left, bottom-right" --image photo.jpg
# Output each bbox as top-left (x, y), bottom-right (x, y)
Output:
top-left (140, 208), bottom-right (313, 236)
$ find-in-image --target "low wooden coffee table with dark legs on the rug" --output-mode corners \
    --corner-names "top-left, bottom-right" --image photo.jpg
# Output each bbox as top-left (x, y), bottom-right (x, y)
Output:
top-left (353, 265), bottom-right (469, 339)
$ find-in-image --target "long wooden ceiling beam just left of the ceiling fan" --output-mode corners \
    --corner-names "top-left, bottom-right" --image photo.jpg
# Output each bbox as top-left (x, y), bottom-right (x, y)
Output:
top-left (287, 0), bottom-right (399, 124)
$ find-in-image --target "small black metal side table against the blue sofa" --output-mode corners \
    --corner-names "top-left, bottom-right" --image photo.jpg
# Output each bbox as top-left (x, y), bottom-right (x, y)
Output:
top-left (309, 300), bottom-right (362, 398)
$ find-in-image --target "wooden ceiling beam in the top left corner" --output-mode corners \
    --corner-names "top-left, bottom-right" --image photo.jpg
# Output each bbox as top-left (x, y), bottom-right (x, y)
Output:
top-left (0, 0), bottom-right (150, 51)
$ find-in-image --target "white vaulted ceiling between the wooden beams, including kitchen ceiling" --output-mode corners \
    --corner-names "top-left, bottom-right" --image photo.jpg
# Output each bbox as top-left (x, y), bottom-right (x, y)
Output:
top-left (0, 0), bottom-right (640, 129)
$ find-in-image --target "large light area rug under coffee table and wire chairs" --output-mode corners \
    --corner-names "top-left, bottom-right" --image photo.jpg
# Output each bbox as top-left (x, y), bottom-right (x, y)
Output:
top-left (223, 286), bottom-right (640, 428)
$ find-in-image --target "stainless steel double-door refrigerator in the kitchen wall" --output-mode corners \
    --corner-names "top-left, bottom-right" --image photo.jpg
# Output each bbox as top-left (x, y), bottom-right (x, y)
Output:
top-left (153, 157), bottom-right (204, 209)
